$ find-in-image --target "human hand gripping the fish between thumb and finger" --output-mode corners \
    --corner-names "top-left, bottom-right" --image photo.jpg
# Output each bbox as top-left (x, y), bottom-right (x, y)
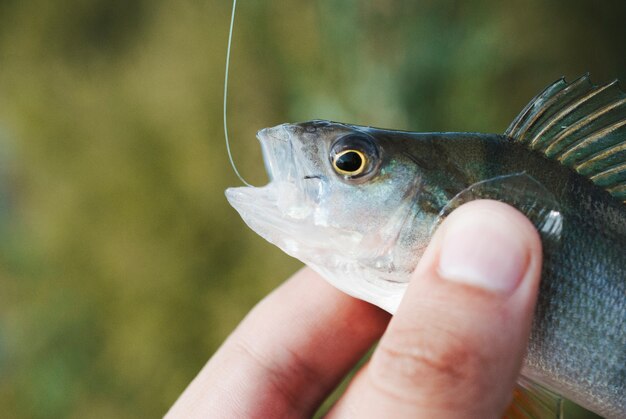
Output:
top-left (168, 201), bottom-right (542, 418)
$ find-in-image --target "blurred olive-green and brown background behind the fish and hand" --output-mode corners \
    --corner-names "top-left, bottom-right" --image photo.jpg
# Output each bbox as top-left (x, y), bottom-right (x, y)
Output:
top-left (0, 0), bottom-right (626, 418)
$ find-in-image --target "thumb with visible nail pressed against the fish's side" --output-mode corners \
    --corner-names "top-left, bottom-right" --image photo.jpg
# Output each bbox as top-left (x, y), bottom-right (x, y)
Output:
top-left (331, 201), bottom-right (541, 418)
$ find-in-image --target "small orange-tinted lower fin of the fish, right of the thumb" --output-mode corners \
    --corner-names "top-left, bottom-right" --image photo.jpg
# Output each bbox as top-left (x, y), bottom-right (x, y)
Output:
top-left (503, 376), bottom-right (564, 419)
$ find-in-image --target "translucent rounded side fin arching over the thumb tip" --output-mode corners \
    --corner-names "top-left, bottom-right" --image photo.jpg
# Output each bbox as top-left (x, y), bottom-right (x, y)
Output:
top-left (431, 172), bottom-right (563, 247)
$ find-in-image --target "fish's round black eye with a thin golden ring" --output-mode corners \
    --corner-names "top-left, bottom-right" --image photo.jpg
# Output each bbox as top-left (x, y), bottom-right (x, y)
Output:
top-left (330, 133), bottom-right (380, 182)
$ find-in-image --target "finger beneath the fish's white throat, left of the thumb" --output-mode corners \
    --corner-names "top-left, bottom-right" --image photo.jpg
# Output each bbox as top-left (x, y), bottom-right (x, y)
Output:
top-left (168, 268), bottom-right (389, 418)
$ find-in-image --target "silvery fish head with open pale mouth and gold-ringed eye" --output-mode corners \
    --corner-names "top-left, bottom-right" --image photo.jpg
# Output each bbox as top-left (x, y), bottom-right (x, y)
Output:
top-left (226, 121), bottom-right (428, 311)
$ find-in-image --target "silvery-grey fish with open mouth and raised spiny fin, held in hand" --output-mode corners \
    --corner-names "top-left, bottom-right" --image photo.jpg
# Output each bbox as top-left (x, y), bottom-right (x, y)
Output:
top-left (226, 74), bottom-right (626, 418)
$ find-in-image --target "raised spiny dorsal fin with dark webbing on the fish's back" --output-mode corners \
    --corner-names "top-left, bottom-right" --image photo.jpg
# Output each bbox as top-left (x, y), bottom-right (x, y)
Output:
top-left (505, 74), bottom-right (626, 204)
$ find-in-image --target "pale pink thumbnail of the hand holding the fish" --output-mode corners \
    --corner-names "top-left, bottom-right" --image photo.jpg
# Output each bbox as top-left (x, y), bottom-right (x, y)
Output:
top-left (439, 211), bottom-right (529, 294)
